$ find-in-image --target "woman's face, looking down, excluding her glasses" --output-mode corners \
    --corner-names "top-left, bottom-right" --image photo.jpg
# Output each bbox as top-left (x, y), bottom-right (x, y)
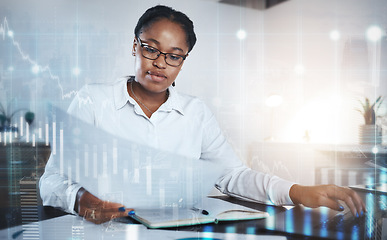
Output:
top-left (133, 19), bottom-right (188, 93)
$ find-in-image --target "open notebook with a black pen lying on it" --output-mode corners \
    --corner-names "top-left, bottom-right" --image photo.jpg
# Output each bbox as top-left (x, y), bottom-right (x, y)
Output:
top-left (131, 198), bottom-right (269, 228)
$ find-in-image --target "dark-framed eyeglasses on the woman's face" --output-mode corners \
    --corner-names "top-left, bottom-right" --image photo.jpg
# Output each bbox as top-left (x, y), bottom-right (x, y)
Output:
top-left (137, 37), bottom-right (187, 67)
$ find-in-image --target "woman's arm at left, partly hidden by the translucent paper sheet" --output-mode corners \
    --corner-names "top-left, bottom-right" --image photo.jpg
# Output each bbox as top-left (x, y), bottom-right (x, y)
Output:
top-left (39, 85), bottom-right (132, 223)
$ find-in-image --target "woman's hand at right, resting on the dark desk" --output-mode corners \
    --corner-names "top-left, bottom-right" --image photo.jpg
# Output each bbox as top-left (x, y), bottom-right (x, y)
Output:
top-left (289, 184), bottom-right (366, 217)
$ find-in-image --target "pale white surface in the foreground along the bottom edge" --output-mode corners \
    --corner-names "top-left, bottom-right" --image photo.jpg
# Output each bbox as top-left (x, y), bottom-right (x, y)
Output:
top-left (0, 215), bottom-right (286, 240)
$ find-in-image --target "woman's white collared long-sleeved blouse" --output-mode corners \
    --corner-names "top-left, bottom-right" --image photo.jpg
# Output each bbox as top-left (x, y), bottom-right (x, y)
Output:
top-left (40, 78), bottom-right (293, 213)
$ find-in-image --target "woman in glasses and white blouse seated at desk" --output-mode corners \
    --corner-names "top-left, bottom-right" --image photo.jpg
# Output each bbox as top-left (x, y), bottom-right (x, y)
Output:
top-left (40, 6), bottom-right (365, 223)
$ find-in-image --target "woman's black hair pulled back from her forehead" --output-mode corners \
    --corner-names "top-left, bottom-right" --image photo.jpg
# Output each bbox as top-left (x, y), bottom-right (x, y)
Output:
top-left (134, 5), bottom-right (196, 52)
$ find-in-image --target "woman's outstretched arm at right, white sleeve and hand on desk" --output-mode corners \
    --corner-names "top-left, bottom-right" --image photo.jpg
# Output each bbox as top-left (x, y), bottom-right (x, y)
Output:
top-left (202, 104), bottom-right (366, 216)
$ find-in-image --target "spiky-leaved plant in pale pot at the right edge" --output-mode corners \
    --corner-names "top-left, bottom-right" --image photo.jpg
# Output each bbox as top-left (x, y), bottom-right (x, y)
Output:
top-left (357, 96), bottom-right (383, 144)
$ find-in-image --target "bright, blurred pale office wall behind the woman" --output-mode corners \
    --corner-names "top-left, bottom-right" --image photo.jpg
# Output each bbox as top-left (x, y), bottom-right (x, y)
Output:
top-left (0, 0), bottom-right (387, 184)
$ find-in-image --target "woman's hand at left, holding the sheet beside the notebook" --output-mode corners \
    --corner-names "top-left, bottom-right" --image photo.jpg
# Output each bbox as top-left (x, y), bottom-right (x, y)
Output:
top-left (78, 191), bottom-right (134, 224)
